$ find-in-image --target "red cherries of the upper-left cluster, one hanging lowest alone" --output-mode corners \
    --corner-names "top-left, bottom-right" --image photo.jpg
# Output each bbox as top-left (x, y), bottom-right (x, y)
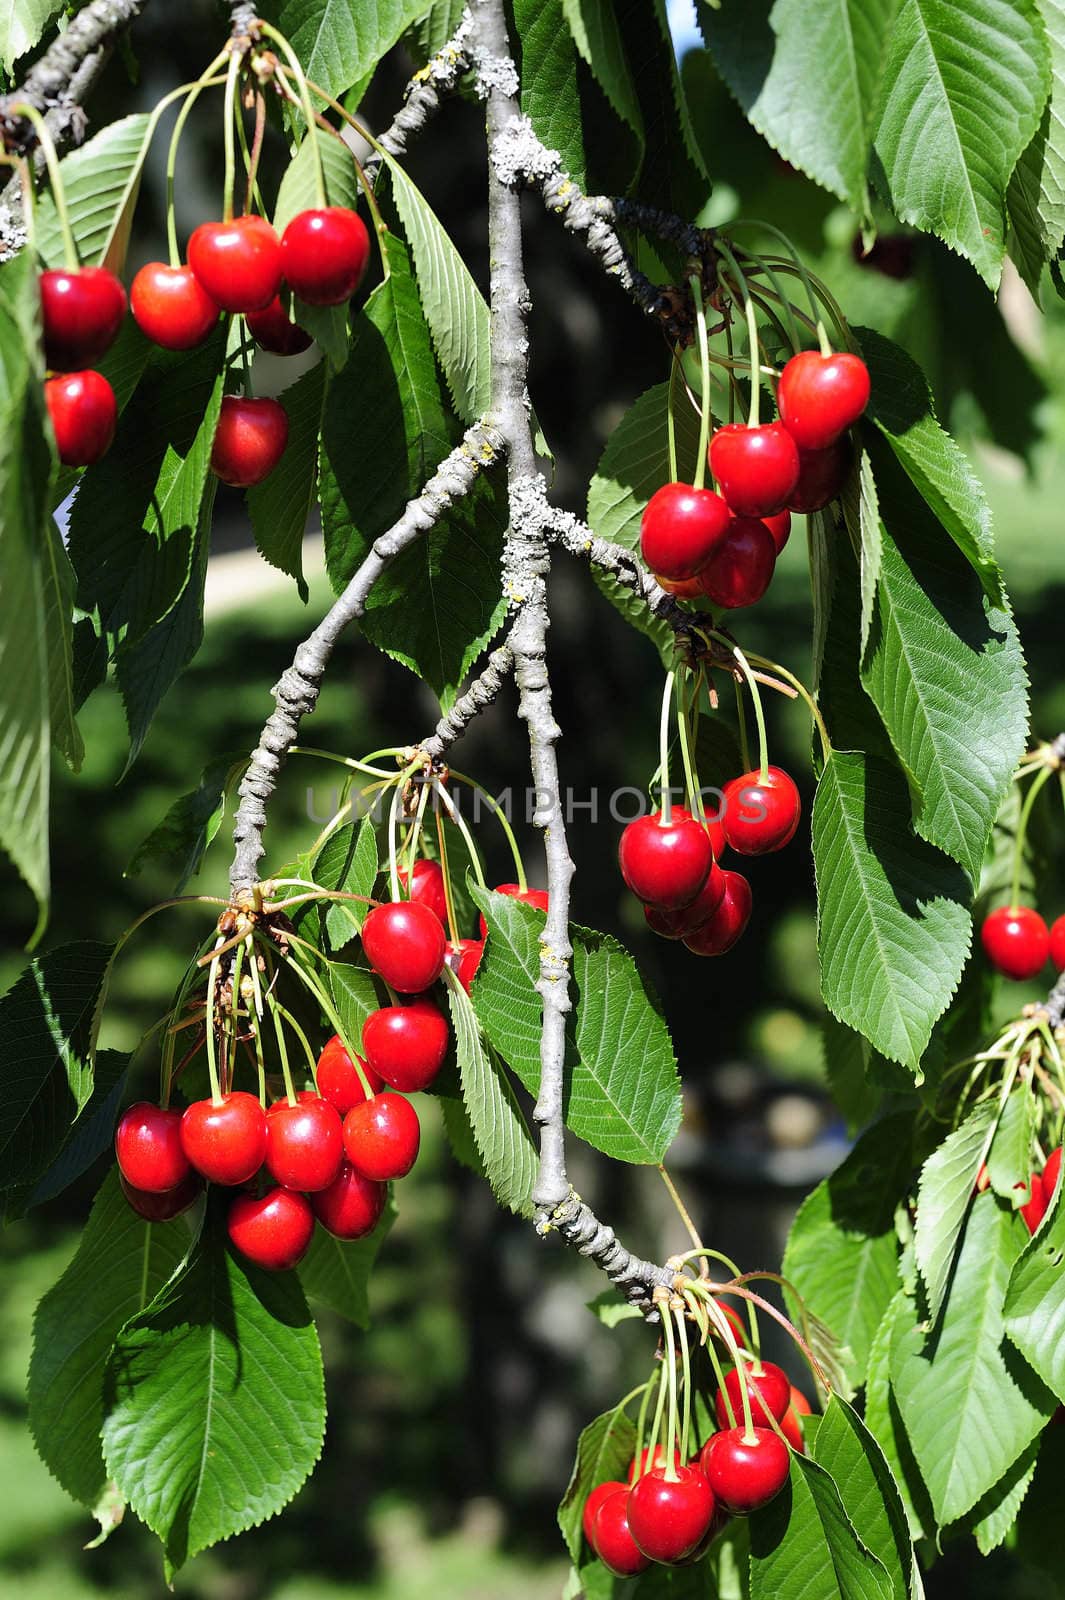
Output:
top-left (40, 206), bottom-right (369, 476)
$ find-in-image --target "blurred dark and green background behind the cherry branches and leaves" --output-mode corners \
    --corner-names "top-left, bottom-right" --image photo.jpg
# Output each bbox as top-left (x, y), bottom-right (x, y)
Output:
top-left (0, 0), bottom-right (1065, 1600)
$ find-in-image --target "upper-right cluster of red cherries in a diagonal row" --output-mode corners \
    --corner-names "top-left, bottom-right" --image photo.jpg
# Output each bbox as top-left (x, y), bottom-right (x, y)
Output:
top-left (640, 350), bottom-right (870, 610)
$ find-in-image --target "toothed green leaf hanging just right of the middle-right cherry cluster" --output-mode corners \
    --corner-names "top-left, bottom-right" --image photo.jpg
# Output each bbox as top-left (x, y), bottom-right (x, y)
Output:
top-left (812, 750), bottom-right (971, 1078)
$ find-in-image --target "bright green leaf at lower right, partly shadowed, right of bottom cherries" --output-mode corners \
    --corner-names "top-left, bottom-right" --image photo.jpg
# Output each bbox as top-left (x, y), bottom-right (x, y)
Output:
top-left (892, 1194), bottom-right (1055, 1526)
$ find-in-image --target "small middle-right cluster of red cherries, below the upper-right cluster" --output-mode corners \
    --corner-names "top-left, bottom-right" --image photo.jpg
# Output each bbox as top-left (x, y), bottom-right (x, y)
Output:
top-left (617, 766), bottom-right (801, 955)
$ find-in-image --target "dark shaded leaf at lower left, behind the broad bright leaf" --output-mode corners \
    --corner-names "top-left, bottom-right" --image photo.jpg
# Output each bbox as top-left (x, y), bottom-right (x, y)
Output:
top-left (29, 1168), bottom-right (189, 1506)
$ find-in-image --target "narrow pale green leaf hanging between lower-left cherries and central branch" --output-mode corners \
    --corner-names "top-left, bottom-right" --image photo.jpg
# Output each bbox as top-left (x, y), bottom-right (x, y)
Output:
top-left (446, 968), bottom-right (537, 1216)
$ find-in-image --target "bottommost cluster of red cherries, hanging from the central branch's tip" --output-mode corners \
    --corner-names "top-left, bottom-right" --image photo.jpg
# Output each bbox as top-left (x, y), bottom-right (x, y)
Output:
top-left (582, 1362), bottom-right (811, 1578)
